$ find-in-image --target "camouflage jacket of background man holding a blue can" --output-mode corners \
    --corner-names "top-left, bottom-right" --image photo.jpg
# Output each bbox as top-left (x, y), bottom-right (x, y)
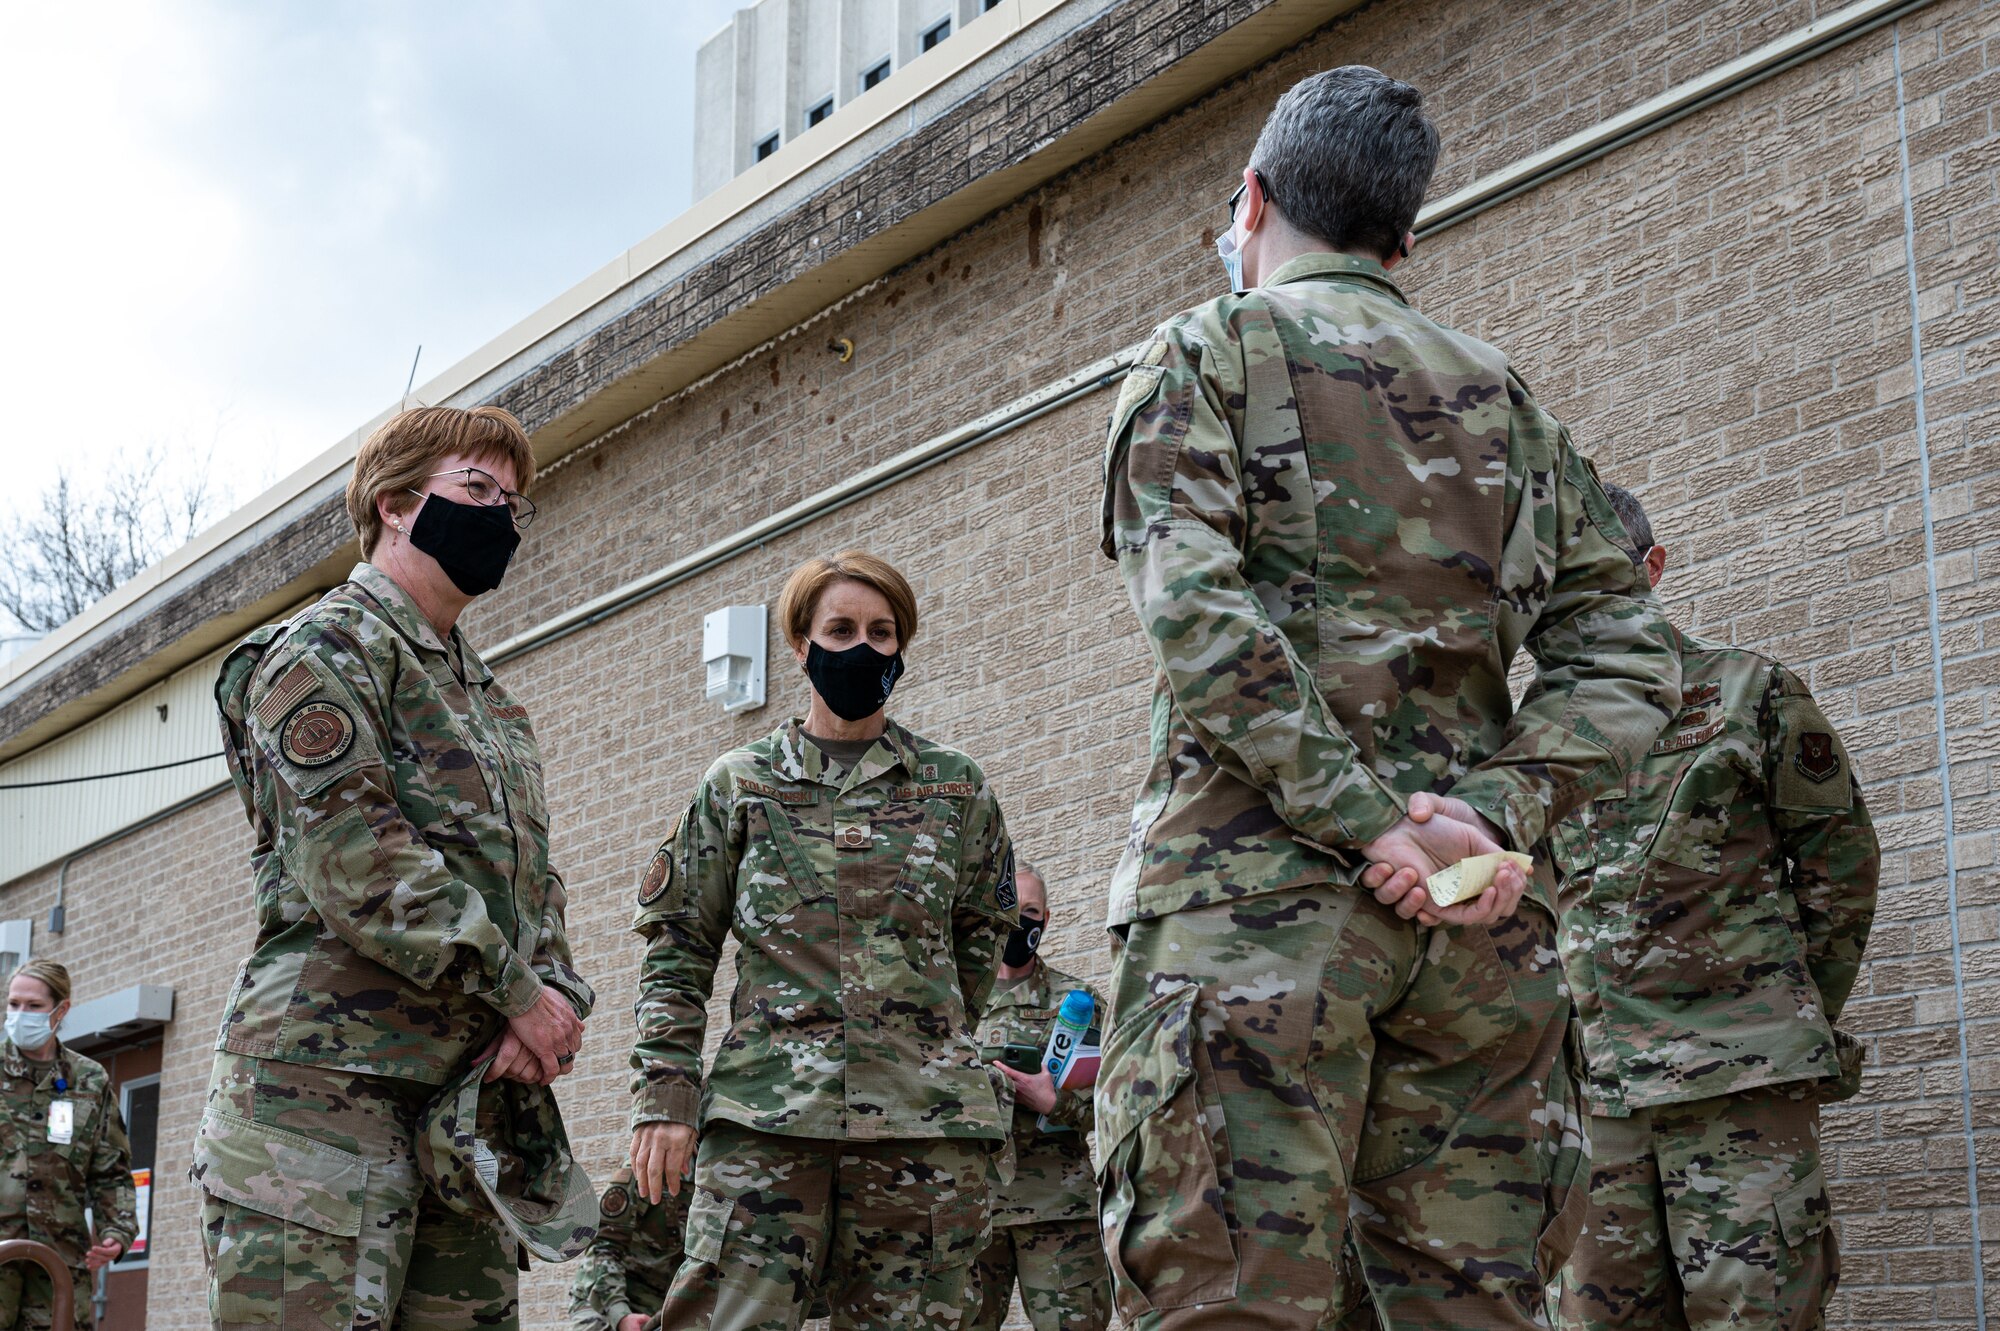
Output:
top-left (980, 961), bottom-right (1110, 1225)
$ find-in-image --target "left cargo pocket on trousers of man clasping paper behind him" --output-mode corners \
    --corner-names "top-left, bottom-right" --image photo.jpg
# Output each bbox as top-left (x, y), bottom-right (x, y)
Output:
top-left (1096, 985), bottom-right (1236, 1323)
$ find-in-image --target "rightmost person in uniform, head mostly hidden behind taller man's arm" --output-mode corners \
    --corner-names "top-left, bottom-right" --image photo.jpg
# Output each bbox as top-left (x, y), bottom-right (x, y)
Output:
top-left (1550, 486), bottom-right (1882, 1331)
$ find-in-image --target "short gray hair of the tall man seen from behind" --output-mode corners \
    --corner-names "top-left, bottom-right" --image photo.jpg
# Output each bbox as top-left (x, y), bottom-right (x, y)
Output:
top-left (1250, 64), bottom-right (1438, 258)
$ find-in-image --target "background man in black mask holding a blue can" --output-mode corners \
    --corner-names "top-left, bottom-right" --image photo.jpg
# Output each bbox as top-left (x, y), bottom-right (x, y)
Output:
top-left (968, 863), bottom-right (1112, 1331)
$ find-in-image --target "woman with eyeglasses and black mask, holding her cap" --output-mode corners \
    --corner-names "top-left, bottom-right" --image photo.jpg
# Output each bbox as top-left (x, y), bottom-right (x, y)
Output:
top-left (194, 408), bottom-right (592, 1331)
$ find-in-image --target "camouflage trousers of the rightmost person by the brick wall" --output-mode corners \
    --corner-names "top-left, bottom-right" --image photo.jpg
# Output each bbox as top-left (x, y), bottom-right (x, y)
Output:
top-left (1550, 1083), bottom-right (1840, 1331)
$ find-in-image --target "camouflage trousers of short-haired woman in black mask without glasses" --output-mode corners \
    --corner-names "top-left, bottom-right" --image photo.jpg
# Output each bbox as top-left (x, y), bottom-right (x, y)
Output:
top-left (660, 1119), bottom-right (994, 1331)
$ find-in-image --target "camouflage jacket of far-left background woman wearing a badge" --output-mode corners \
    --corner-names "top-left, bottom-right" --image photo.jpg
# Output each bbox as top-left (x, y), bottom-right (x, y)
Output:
top-left (0, 1039), bottom-right (138, 1263)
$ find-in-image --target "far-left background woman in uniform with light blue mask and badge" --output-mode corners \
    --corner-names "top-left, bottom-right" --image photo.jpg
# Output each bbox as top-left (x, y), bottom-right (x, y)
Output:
top-left (0, 961), bottom-right (138, 1331)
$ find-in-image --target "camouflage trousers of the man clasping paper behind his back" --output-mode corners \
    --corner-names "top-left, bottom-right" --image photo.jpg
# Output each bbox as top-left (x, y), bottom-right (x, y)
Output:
top-left (1096, 885), bottom-right (1588, 1331)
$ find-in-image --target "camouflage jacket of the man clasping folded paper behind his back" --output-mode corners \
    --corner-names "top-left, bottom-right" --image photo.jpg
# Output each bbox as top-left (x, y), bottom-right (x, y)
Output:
top-left (1104, 254), bottom-right (1680, 925)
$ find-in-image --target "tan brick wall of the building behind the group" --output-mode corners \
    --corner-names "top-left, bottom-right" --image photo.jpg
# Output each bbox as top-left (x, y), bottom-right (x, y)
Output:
top-left (0, 0), bottom-right (2000, 1329)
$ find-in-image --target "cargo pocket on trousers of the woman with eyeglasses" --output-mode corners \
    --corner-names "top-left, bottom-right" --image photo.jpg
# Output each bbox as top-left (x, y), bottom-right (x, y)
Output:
top-left (188, 1109), bottom-right (366, 1329)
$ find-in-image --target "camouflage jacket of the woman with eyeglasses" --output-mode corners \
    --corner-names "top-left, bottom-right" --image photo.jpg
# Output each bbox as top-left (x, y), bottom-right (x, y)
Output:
top-left (216, 564), bottom-right (592, 1085)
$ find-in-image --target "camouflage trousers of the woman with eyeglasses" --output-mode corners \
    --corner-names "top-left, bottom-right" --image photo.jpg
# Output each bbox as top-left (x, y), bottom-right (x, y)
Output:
top-left (196, 1053), bottom-right (520, 1331)
